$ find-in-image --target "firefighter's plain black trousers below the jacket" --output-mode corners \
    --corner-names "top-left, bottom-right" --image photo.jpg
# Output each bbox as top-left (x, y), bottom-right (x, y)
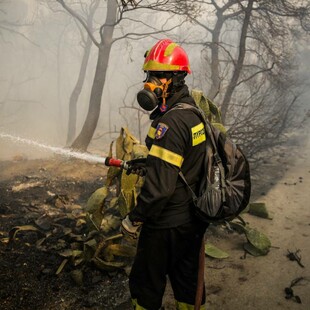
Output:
top-left (129, 222), bottom-right (206, 310)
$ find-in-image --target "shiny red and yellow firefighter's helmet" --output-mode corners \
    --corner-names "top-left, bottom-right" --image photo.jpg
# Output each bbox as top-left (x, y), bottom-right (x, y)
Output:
top-left (143, 39), bottom-right (191, 73)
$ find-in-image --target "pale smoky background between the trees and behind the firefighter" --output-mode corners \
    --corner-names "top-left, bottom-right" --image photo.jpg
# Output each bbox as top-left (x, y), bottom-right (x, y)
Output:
top-left (0, 0), bottom-right (310, 164)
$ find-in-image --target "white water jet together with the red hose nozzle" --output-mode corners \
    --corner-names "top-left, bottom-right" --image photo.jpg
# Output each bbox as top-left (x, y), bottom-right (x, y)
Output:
top-left (0, 133), bottom-right (128, 170)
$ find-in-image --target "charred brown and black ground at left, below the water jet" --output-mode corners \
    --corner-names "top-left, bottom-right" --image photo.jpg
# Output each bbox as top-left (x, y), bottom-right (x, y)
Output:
top-left (0, 159), bottom-right (129, 310)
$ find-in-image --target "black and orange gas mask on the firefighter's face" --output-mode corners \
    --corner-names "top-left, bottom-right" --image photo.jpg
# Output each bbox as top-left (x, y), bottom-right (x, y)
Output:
top-left (137, 73), bottom-right (172, 111)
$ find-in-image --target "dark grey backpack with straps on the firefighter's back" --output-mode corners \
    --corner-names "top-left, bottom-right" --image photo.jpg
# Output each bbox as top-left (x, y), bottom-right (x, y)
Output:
top-left (175, 103), bottom-right (251, 223)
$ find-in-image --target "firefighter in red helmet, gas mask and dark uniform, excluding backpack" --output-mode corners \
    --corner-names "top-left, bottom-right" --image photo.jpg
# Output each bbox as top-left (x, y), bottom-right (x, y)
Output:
top-left (121, 39), bottom-right (206, 310)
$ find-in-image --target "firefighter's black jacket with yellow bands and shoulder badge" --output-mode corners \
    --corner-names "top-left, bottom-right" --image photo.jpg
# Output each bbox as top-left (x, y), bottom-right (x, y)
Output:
top-left (129, 85), bottom-right (206, 228)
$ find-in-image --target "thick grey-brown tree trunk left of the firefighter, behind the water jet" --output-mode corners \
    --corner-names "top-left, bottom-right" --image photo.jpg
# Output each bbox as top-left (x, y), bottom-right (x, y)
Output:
top-left (71, 0), bottom-right (118, 151)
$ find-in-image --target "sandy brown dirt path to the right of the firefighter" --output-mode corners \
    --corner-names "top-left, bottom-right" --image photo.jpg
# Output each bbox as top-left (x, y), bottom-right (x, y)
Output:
top-left (206, 136), bottom-right (310, 310)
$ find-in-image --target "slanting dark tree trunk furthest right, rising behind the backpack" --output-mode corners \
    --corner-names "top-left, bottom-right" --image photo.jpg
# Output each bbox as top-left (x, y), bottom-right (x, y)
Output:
top-left (221, 0), bottom-right (254, 124)
